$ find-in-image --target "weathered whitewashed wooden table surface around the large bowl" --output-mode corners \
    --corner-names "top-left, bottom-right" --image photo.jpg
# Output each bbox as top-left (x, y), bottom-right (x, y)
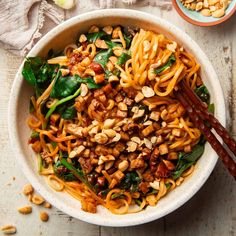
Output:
top-left (0, 4), bottom-right (236, 236)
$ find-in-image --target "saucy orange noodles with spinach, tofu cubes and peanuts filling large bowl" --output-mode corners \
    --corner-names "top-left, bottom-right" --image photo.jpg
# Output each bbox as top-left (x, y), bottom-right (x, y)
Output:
top-left (23, 26), bottom-right (209, 214)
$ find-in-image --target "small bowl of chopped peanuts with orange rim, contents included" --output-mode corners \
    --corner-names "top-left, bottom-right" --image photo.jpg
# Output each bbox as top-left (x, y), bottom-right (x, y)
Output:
top-left (172, 0), bottom-right (236, 26)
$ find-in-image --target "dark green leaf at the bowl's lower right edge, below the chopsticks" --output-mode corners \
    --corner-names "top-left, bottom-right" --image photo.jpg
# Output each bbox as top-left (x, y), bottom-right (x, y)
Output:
top-left (172, 144), bottom-right (204, 179)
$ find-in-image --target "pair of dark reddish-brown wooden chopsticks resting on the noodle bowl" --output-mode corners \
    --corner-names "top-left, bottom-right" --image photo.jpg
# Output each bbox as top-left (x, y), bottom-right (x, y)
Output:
top-left (176, 80), bottom-right (236, 180)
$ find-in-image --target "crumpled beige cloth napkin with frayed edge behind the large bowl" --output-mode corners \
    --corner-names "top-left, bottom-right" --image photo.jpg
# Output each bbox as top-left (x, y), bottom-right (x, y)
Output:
top-left (0, 0), bottom-right (171, 56)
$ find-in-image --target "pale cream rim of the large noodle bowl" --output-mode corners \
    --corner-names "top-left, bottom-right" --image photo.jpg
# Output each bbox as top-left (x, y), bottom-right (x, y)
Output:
top-left (8, 9), bottom-right (226, 227)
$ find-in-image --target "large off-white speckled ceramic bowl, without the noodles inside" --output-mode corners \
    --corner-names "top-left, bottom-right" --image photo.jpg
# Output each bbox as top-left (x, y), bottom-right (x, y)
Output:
top-left (8, 9), bottom-right (225, 227)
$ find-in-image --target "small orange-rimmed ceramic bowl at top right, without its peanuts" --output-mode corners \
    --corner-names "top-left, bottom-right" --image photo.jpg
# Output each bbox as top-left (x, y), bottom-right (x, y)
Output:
top-left (172, 0), bottom-right (236, 26)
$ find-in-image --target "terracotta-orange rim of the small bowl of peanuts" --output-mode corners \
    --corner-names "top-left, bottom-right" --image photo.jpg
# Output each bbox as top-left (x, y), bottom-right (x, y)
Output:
top-left (172, 0), bottom-right (236, 27)
